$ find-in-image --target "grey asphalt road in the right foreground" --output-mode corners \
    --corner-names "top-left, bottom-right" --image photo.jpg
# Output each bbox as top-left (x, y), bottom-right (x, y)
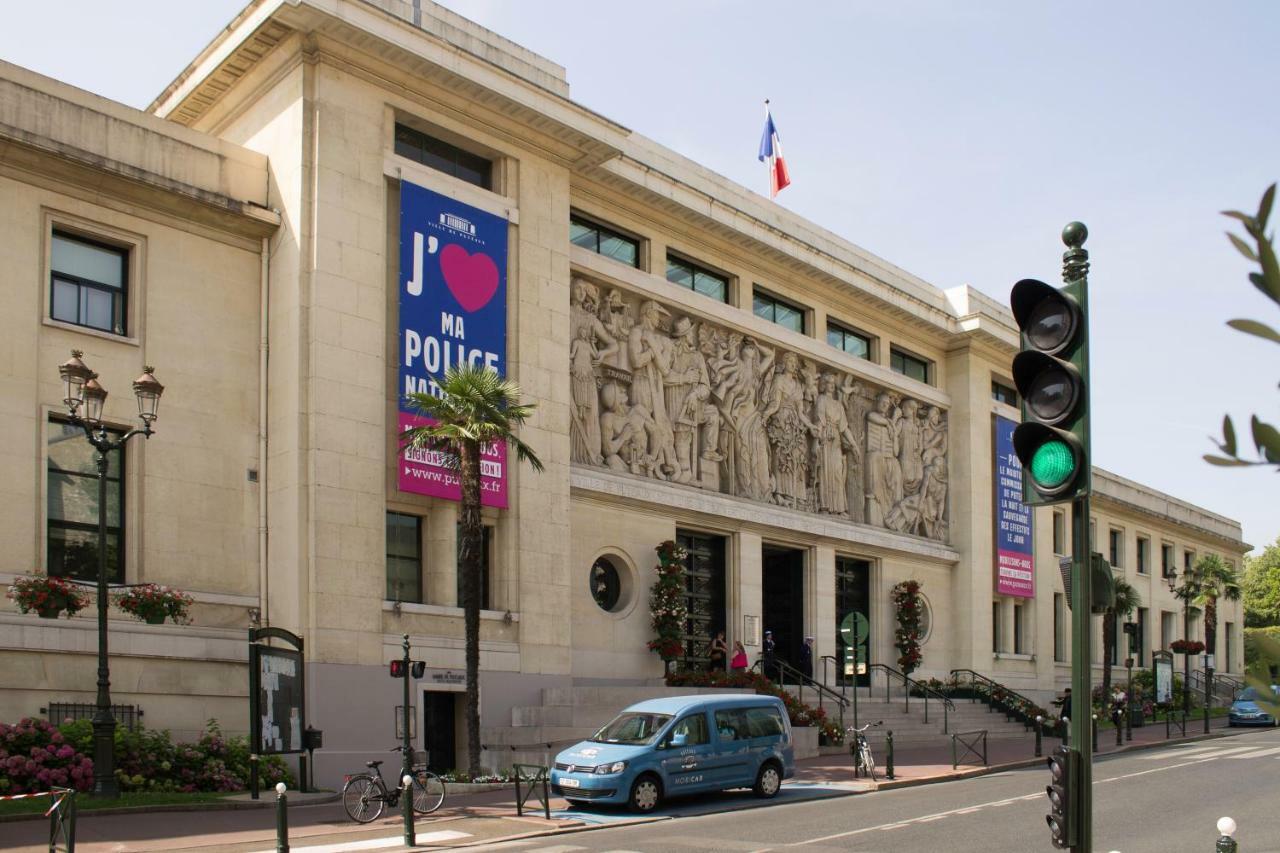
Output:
top-left (483, 730), bottom-right (1280, 853)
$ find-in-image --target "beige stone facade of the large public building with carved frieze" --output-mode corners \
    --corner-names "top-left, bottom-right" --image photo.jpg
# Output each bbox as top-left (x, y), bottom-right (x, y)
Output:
top-left (0, 0), bottom-right (1248, 779)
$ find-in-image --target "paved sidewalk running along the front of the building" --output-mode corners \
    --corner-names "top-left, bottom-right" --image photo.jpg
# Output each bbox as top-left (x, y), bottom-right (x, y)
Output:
top-left (0, 719), bottom-right (1244, 853)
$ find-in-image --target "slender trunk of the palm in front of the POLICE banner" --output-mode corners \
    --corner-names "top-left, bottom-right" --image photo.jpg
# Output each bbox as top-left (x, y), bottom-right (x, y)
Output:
top-left (458, 441), bottom-right (484, 776)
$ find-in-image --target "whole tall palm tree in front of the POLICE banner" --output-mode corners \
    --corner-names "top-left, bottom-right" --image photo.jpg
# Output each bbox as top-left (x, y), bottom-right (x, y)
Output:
top-left (401, 364), bottom-right (543, 776)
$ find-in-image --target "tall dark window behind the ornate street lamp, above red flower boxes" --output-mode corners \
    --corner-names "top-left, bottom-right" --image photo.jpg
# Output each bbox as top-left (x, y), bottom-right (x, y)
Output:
top-left (47, 420), bottom-right (124, 583)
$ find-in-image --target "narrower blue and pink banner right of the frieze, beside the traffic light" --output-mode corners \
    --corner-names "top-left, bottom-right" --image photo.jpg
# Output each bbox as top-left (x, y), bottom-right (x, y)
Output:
top-left (992, 415), bottom-right (1036, 598)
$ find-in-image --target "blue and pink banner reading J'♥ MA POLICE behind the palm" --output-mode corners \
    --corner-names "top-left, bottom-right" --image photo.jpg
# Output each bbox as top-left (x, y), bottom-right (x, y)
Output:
top-left (397, 181), bottom-right (507, 507)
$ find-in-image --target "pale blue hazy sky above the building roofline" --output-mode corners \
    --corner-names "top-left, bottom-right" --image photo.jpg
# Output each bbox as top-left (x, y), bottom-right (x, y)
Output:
top-left (0, 0), bottom-right (1280, 546)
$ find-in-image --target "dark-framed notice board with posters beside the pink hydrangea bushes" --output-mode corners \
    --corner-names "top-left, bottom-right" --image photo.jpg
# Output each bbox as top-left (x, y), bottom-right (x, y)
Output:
top-left (248, 628), bottom-right (307, 756)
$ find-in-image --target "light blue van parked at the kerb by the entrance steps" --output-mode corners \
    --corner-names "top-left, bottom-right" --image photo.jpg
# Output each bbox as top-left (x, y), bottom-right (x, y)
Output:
top-left (552, 694), bottom-right (795, 812)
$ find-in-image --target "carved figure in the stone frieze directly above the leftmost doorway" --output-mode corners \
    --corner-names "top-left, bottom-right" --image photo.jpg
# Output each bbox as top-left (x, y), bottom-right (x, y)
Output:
top-left (667, 316), bottom-right (723, 483)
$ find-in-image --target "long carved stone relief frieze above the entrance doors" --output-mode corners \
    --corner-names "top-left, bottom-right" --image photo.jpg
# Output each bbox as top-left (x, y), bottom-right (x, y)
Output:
top-left (570, 278), bottom-right (947, 540)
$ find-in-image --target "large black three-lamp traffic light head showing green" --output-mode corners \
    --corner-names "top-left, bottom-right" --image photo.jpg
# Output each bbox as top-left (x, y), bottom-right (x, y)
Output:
top-left (1009, 223), bottom-right (1091, 506)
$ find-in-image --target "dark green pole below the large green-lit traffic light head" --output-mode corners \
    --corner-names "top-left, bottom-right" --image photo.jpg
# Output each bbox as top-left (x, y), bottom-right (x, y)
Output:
top-left (1070, 497), bottom-right (1093, 853)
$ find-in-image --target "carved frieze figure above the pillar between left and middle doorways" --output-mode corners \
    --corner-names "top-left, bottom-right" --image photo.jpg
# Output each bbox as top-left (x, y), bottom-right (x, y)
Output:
top-left (716, 341), bottom-right (773, 501)
